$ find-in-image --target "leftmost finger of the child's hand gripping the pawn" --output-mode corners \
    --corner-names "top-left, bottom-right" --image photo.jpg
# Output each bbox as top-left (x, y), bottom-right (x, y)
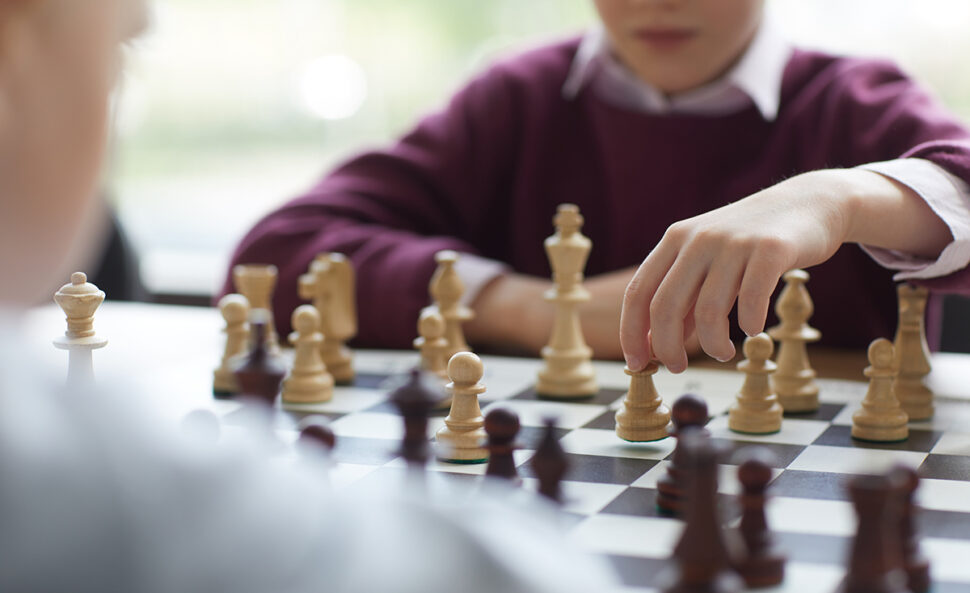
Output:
top-left (620, 245), bottom-right (676, 371)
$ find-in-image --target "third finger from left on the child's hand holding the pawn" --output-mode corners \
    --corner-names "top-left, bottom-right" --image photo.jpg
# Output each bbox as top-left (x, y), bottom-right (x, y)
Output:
top-left (694, 257), bottom-right (744, 361)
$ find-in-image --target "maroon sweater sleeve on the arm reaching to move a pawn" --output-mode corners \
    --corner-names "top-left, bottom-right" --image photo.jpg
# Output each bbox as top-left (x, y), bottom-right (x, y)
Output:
top-left (832, 60), bottom-right (970, 294)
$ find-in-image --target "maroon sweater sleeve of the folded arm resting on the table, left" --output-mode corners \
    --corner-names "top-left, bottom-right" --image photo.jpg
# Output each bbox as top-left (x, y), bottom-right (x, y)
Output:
top-left (226, 67), bottom-right (516, 348)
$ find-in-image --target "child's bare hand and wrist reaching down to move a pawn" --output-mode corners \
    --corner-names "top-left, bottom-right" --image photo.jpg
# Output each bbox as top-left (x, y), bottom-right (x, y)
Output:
top-left (620, 169), bottom-right (949, 373)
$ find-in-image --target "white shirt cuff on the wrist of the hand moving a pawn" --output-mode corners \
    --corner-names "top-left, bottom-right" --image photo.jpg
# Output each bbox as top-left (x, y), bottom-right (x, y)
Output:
top-left (858, 158), bottom-right (970, 281)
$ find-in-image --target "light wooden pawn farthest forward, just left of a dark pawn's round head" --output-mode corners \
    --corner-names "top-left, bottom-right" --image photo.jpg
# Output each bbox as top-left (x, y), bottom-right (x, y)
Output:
top-left (436, 352), bottom-right (488, 463)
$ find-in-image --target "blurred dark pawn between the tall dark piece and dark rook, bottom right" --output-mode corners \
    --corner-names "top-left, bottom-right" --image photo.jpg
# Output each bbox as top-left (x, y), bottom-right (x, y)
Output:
top-left (736, 447), bottom-right (785, 588)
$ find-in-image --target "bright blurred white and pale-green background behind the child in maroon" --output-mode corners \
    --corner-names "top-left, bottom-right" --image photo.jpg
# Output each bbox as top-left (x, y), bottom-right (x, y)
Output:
top-left (109, 0), bottom-right (970, 294)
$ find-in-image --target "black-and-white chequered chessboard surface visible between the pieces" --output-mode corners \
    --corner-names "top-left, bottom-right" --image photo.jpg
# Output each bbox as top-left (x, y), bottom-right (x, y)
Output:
top-left (213, 352), bottom-right (970, 593)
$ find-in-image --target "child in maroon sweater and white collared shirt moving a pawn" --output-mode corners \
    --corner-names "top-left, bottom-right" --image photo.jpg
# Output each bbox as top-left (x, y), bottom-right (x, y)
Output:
top-left (227, 0), bottom-right (970, 371)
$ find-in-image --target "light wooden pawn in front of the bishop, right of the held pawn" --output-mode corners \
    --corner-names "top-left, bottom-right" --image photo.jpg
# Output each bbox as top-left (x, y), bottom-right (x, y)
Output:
top-left (728, 332), bottom-right (783, 434)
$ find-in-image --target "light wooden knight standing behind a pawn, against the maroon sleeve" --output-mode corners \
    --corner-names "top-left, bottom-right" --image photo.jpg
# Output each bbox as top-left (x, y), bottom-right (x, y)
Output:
top-left (297, 253), bottom-right (357, 385)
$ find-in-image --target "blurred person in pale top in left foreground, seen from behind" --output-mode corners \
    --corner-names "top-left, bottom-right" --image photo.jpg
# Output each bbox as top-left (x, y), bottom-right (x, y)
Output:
top-left (0, 0), bottom-right (609, 593)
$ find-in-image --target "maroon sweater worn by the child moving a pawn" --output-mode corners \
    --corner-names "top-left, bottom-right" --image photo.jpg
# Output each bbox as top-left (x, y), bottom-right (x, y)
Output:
top-left (226, 40), bottom-right (970, 347)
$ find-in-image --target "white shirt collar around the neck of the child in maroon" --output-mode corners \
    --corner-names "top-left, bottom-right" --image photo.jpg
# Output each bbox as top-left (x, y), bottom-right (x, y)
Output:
top-left (562, 17), bottom-right (792, 121)
